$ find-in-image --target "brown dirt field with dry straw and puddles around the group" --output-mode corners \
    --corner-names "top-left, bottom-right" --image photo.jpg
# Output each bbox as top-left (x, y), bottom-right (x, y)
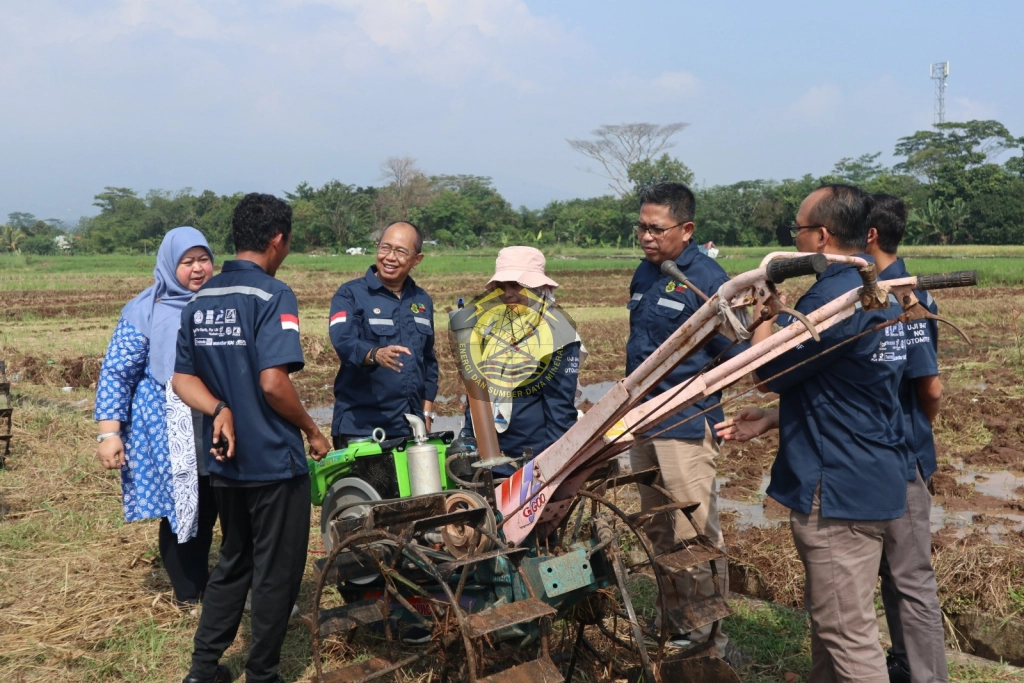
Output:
top-left (0, 258), bottom-right (1024, 681)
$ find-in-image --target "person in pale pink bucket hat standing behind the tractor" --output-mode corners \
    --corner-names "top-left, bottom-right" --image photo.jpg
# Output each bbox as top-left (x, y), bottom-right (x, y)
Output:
top-left (461, 247), bottom-right (587, 476)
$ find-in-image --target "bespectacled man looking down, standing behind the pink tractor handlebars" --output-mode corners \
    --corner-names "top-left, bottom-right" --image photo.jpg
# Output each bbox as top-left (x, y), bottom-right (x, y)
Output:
top-left (626, 182), bottom-right (746, 656)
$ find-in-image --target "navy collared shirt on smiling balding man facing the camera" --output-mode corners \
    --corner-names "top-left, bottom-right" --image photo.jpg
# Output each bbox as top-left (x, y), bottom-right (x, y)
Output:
top-left (328, 265), bottom-right (438, 436)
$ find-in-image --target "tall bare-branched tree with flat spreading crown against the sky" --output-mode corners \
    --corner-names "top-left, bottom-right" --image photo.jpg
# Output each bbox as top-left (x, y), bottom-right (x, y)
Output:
top-left (566, 122), bottom-right (689, 197)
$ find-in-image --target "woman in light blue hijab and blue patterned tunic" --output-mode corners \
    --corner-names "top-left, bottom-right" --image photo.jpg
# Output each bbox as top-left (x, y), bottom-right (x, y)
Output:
top-left (94, 227), bottom-right (218, 603)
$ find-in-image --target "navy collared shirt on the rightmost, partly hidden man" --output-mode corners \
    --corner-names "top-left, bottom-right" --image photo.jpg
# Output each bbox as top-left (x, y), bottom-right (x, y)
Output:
top-left (879, 258), bottom-right (939, 481)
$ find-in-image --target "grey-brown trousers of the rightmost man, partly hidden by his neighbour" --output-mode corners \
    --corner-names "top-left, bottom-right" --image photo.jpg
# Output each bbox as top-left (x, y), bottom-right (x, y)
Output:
top-left (879, 469), bottom-right (949, 683)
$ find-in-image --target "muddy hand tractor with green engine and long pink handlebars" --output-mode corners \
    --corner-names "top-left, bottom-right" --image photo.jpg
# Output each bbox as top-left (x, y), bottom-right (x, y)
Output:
top-left (304, 253), bottom-right (976, 683)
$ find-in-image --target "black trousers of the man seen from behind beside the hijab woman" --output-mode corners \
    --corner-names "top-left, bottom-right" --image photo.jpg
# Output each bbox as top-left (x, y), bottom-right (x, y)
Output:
top-left (189, 475), bottom-right (309, 683)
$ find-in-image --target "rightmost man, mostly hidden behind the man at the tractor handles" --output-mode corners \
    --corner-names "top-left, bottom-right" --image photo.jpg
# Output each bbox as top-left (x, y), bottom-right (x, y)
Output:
top-left (867, 195), bottom-right (949, 683)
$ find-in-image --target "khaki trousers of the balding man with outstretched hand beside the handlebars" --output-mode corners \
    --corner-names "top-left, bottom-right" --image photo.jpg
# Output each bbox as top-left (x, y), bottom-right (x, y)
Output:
top-left (790, 492), bottom-right (889, 683)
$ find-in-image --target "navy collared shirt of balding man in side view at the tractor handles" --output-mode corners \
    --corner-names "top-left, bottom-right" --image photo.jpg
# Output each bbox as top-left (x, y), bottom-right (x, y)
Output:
top-left (758, 254), bottom-right (907, 520)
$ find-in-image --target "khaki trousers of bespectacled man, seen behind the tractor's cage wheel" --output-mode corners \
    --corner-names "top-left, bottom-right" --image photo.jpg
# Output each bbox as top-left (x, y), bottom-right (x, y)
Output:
top-left (630, 420), bottom-right (729, 653)
